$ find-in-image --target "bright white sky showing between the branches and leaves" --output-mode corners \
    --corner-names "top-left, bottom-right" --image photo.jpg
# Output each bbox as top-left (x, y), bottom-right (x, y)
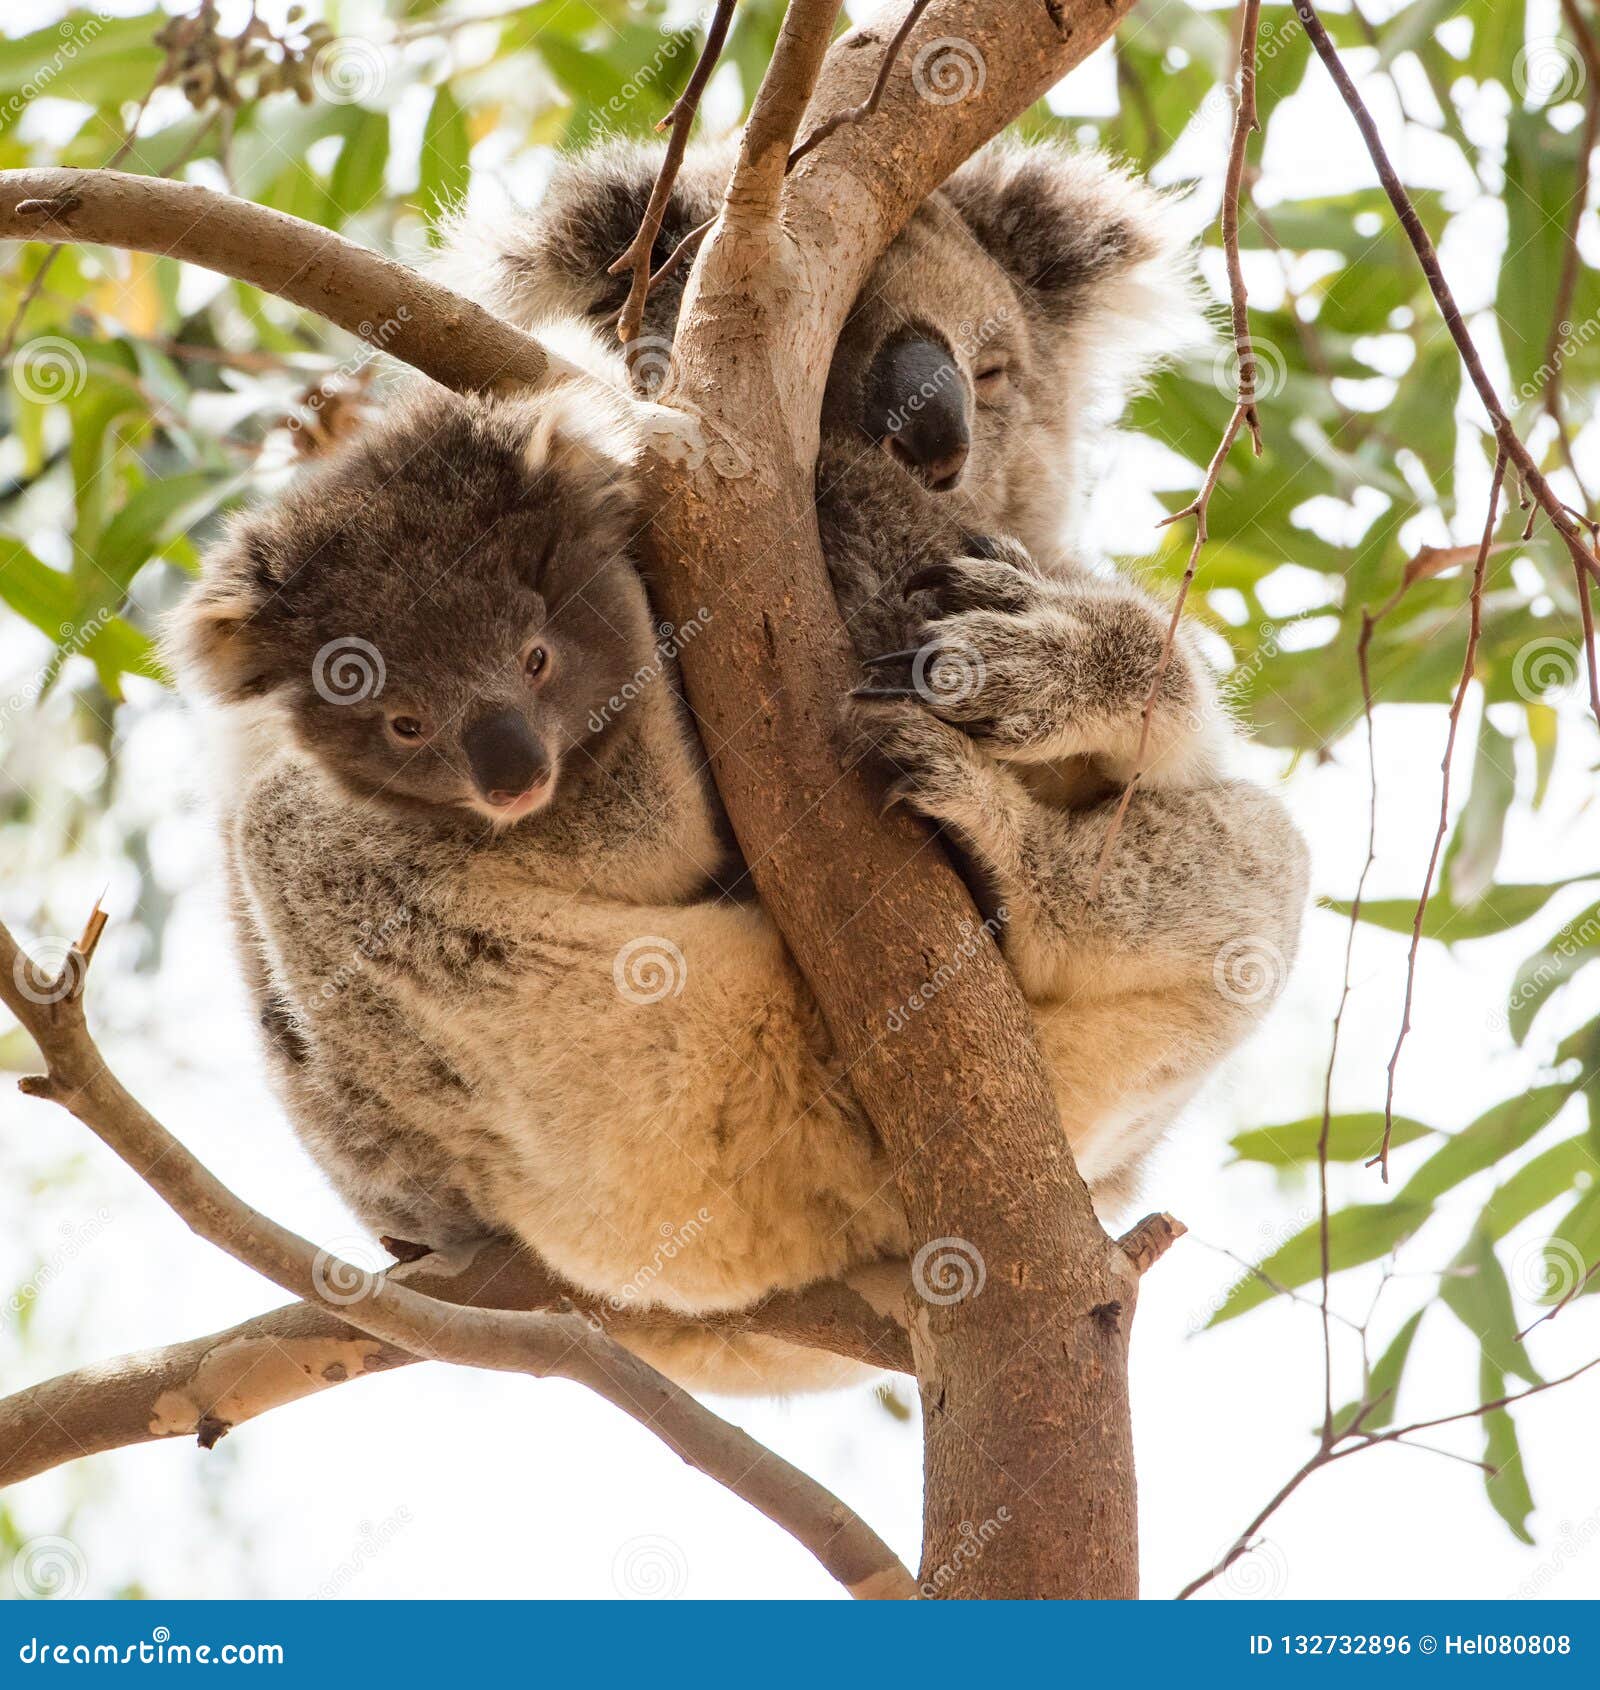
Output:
top-left (0, 0), bottom-right (1600, 1597)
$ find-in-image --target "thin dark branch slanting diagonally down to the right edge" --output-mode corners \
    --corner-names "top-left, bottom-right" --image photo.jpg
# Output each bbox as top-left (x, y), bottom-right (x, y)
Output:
top-left (1294, 0), bottom-right (1600, 722)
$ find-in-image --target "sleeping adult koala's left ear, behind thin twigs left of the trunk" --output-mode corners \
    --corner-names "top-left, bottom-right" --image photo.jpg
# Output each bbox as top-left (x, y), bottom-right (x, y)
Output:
top-left (431, 142), bottom-right (733, 348)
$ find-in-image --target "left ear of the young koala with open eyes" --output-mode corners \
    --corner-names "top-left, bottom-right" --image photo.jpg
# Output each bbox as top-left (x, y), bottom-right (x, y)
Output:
top-left (162, 515), bottom-right (293, 703)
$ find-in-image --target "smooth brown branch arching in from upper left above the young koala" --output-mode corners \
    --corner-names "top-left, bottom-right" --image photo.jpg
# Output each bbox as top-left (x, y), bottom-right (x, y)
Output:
top-left (0, 169), bottom-right (576, 392)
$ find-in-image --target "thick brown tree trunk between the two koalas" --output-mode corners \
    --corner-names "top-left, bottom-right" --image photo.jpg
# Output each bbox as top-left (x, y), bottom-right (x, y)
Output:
top-left (650, 0), bottom-right (1137, 1597)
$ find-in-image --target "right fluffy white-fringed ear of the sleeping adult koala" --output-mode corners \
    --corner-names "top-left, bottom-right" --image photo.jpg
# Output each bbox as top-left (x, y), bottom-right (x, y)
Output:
top-left (941, 142), bottom-right (1205, 362)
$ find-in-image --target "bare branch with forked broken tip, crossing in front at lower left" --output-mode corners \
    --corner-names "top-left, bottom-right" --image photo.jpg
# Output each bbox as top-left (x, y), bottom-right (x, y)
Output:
top-left (0, 909), bottom-right (916, 1597)
